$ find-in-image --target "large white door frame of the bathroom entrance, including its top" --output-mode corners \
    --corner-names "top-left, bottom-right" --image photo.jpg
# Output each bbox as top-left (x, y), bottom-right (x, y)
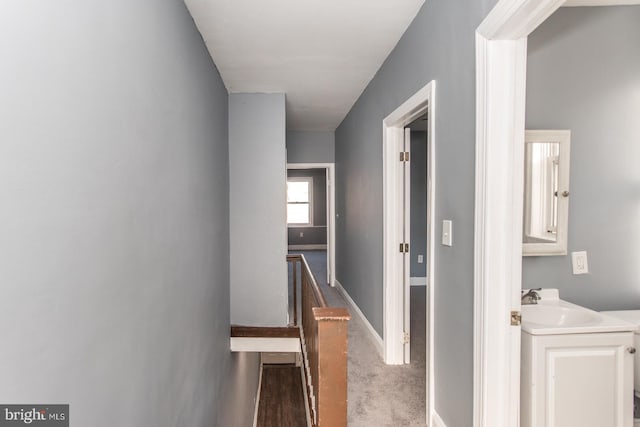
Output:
top-left (473, 0), bottom-right (638, 427)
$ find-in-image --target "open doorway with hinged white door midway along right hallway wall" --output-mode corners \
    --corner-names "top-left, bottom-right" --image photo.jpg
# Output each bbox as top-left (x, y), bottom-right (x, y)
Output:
top-left (383, 81), bottom-right (435, 424)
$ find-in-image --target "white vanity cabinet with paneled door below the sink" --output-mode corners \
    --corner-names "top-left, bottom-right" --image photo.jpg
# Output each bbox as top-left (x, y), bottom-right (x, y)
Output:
top-left (520, 331), bottom-right (634, 427)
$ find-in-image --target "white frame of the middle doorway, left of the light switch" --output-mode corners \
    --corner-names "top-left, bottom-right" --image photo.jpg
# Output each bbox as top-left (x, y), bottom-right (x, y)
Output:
top-left (382, 81), bottom-right (436, 425)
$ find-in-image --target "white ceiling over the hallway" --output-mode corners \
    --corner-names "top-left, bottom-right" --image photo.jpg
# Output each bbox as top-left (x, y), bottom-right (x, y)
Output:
top-left (185, 0), bottom-right (424, 130)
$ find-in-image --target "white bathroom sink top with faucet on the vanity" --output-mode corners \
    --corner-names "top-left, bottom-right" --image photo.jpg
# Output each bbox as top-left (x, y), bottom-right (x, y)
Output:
top-left (521, 289), bottom-right (636, 335)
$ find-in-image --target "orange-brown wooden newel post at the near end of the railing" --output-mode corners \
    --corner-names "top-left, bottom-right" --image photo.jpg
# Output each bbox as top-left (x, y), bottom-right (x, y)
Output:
top-left (313, 307), bottom-right (351, 427)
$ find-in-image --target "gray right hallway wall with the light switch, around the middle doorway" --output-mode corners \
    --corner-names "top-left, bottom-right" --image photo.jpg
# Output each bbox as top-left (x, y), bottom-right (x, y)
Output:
top-left (336, 0), bottom-right (495, 427)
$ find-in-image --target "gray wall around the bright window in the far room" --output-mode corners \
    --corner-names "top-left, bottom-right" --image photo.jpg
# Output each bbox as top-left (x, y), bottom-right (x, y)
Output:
top-left (287, 169), bottom-right (327, 245)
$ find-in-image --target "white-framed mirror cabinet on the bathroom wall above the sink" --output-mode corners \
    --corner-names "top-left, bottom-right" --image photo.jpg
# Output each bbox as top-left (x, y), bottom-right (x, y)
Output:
top-left (522, 130), bottom-right (571, 256)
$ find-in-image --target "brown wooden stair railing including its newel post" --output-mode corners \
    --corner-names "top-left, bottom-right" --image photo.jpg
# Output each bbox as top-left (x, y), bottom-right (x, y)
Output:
top-left (287, 254), bottom-right (351, 427)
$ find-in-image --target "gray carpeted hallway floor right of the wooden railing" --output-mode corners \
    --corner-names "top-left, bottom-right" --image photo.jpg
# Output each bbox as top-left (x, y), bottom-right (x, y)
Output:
top-left (292, 251), bottom-right (426, 427)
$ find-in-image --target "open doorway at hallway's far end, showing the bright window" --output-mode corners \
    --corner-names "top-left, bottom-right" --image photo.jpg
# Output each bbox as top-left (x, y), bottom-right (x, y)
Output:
top-left (287, 163), bottom-right (335, 286)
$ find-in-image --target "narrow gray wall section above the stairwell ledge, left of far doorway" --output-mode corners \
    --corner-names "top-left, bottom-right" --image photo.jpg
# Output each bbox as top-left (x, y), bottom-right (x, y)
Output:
top-left (229, 93), bottom-right (288, 326)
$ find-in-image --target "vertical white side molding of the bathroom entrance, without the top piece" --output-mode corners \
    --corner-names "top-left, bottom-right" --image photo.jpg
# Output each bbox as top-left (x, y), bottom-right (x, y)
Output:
top-left (474, 36), bottom-right (526, 427)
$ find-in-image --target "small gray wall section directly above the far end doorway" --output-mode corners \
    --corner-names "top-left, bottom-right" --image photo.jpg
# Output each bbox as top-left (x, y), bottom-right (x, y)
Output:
top-left (287, 131), bottom-right (335, 163)
